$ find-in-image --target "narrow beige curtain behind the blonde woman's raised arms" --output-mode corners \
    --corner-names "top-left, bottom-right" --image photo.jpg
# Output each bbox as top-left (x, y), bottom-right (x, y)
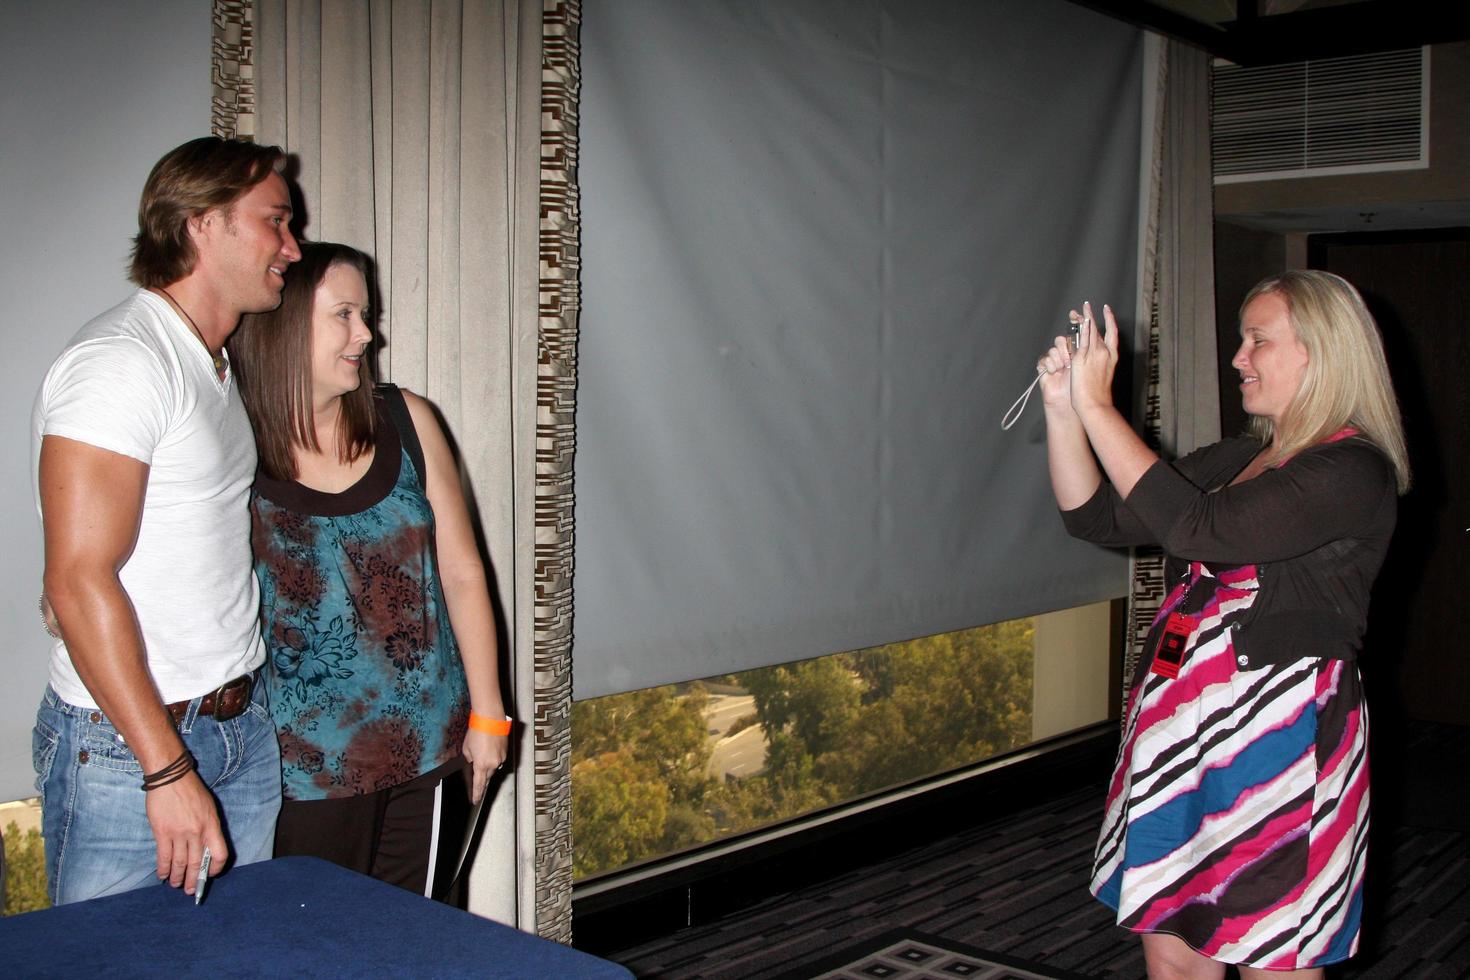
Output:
top-left (1123, 35), bottom-right (1220, 696)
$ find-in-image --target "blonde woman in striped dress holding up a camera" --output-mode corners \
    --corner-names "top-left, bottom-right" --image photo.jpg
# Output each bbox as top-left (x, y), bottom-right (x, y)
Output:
top-left (1038, 272), bottom-right (1410, 980)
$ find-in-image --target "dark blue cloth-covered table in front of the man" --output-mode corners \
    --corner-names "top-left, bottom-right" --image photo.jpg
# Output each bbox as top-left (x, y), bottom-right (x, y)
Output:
top-left (0, 858), bottom-right (632, 980)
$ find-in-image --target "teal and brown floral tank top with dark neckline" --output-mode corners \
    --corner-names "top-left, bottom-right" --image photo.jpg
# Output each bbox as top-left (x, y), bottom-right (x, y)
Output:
top-left (250, 388), bottom-right (469, 801)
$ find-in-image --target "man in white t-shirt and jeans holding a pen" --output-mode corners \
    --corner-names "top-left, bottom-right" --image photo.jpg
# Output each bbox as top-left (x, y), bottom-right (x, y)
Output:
top-left (31, 137), bottom-right (300, 904)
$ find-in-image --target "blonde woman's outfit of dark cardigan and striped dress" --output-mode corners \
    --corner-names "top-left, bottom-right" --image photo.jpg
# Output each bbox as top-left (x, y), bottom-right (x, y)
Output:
top-left (1063, 430), bottom-right (1398, 970)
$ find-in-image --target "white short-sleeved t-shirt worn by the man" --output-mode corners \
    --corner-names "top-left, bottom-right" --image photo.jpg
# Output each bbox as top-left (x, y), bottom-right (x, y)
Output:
top-left (31, 289), bottom-right (265, 708)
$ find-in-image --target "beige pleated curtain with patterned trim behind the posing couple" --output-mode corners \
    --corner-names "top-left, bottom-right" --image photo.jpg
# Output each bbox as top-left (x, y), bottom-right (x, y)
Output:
top-left (215, 0), bottom-right (579, 942)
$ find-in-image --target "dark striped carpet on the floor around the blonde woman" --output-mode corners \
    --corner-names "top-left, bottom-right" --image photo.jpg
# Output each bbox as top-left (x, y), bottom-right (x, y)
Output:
top-left (610, 717), bottom-right (1470, 980)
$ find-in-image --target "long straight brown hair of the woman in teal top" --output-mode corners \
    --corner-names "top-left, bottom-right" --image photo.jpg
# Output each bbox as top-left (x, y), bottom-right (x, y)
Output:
top-left (228, 241), bottom-right (376, 480)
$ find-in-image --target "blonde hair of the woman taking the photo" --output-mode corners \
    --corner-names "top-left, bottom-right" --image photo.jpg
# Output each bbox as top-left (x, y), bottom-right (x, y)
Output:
top-left (1241, 269), bottom-right (1410, 494)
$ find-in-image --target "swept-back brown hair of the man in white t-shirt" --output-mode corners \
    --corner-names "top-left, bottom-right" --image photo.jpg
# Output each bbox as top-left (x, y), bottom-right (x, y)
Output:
top-left (128, 137), bottom-right (285, 287)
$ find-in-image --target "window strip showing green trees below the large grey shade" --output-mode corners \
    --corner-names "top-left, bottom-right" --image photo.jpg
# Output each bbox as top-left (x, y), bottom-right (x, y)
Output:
top-left (572, 602), bottom-right (1114, 879)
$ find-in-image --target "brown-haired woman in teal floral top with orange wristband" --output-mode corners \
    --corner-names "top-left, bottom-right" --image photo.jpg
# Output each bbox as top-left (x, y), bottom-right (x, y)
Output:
top-left (229, 242), bottom-right (510, 898)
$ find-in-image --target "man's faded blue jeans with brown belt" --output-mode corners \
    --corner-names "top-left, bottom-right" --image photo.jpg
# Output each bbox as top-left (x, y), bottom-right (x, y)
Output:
top-left (31, 679), bottom-right (281, 905)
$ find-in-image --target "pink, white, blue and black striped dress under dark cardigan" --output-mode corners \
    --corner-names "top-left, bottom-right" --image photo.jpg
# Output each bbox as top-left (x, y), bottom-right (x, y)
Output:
top-left (1092, 561), bottom-right (1369, 970)
